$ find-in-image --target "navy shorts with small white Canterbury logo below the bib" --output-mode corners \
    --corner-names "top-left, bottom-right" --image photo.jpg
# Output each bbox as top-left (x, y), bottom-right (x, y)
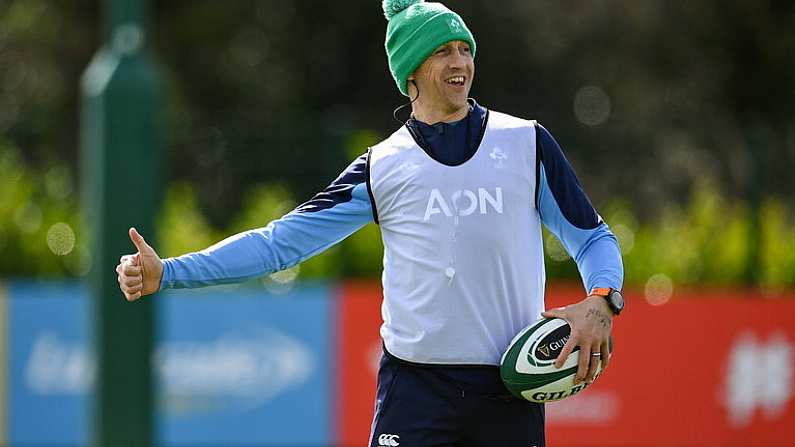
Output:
top-left (369, 351), bottom-right (544, 447)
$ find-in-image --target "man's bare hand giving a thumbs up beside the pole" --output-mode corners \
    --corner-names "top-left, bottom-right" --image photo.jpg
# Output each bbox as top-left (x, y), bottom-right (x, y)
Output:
top-left (116, 228), bottom-right (163, 301)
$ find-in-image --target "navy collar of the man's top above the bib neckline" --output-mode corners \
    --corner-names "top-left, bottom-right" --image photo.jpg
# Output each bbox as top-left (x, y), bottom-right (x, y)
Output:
top-left (406, 98), bottom-right (489, 166)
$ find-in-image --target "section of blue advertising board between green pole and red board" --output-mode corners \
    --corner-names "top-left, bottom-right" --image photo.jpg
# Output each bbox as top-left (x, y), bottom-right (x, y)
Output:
top-left (155, 287), bottom-right (334, 446)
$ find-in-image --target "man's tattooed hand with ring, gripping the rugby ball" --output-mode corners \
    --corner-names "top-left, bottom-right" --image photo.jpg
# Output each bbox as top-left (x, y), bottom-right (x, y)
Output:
top-left (541, 295), bottom-right (613, 384)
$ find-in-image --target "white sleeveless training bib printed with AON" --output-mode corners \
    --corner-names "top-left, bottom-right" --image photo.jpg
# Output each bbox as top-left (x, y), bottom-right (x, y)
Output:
top-left (369, 112), bottom-right (545, 365)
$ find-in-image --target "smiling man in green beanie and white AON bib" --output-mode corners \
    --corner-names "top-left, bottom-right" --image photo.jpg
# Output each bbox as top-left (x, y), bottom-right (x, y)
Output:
top-left (117, 0), bottom-right (623, 447)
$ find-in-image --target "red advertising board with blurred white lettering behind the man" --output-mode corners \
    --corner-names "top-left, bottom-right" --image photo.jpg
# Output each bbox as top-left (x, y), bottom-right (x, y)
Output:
top-left (337, 284), bottom-right (795, 447)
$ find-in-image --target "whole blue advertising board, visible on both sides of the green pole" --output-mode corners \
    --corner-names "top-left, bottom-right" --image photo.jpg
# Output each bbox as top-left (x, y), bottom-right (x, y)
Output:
top-left (7, 282), bottom-right (335, 446)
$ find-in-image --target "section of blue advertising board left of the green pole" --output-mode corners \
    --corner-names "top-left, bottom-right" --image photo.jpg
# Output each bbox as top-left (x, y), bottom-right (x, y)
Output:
top-left (6, 282), bottom-right (94, 445)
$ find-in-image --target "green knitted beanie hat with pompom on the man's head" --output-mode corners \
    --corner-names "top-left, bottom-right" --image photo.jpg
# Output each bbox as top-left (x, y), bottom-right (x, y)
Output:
top-left (382, 0), bottom-right (475, 96)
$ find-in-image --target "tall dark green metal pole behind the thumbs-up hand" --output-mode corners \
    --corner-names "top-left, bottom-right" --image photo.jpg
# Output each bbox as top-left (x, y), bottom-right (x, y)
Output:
top-left (80, 0), bottom-right (161, 447)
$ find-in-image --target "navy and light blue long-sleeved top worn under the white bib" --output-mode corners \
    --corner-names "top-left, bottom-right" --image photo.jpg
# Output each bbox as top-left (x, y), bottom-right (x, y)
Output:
top-left (160, 101), bottom-right (623, 290)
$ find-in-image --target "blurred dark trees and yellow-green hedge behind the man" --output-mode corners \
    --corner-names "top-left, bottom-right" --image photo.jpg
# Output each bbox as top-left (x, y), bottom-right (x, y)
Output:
top-left (0, 0), bottom-right (795, 294)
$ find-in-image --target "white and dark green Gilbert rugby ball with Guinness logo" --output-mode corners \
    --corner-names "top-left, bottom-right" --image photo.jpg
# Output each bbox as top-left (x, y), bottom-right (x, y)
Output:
top-left (500, 318), bottom-right (613, 403)
